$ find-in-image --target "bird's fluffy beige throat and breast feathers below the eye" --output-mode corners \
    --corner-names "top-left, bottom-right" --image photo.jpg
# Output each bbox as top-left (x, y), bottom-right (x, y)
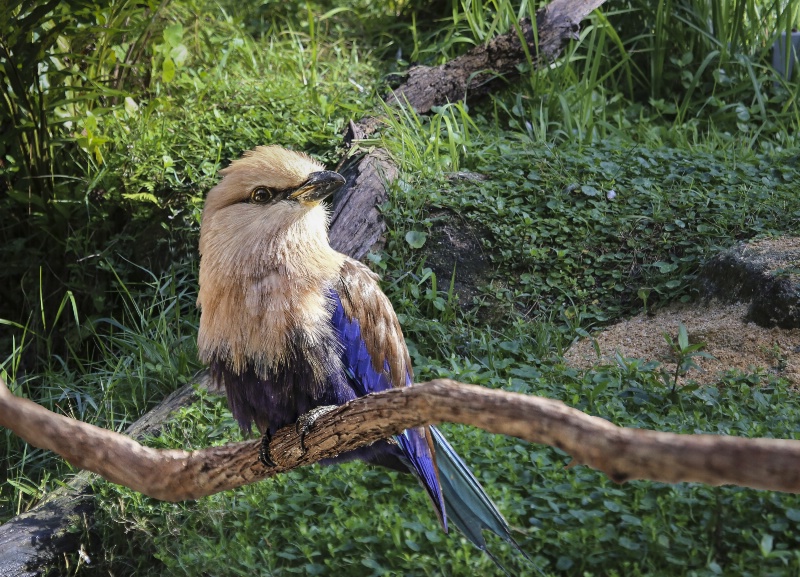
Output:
top-left (198, 199), bottom-right (345, 377)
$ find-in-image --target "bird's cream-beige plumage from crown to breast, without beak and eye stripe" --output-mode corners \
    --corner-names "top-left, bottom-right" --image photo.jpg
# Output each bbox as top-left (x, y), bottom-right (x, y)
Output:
top-left (197, 146), bottom-right (344, 374)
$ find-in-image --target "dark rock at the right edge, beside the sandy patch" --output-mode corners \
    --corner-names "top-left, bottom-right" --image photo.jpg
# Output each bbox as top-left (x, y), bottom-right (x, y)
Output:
top-left (698, 237), bottom-right (800, 329)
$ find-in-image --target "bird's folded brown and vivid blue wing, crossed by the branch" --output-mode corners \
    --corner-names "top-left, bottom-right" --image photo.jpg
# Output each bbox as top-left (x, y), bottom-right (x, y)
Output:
top-left (331, 259), bottom-right (447, 530)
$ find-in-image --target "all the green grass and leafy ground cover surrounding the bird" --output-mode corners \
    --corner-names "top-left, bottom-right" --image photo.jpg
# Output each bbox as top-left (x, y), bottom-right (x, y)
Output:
top-left (0, 0), bottom-right (800, 575)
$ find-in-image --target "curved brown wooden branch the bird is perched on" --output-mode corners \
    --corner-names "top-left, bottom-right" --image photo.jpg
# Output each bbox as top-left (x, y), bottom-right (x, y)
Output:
top-left (0, 379), bottom-right (800, 501)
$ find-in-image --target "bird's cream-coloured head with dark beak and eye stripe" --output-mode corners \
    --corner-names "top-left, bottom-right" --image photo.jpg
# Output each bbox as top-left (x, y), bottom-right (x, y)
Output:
top-left (200, 146), bottom-right (345, 274)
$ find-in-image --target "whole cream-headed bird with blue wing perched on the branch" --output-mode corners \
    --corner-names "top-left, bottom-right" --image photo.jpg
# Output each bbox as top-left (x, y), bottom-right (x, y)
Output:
top-left (197, 145), bottom-right (527, 559)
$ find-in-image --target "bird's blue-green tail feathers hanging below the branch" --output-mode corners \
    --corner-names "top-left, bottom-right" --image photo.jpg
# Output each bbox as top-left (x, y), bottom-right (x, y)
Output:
top-left (430, 427), bottom-right (532, 568)
